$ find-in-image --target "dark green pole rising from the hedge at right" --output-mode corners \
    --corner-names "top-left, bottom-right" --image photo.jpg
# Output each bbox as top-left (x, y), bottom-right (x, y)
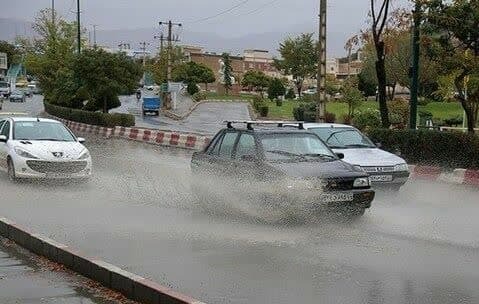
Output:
top-left (409, 0), bottom-right (421, 130)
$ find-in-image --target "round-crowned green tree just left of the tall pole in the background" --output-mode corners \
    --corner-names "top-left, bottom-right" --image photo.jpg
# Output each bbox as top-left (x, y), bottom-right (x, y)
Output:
top-left (274, 33), bottom-right (318, 97)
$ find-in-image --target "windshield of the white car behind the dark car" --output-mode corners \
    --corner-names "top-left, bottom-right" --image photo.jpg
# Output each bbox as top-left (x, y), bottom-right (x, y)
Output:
top-left (309, 128), bottom-right (376, 149)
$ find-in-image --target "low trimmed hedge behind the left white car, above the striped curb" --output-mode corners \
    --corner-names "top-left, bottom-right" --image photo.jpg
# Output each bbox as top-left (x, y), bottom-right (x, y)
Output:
top-left (43, 102), bottom-right (135, 127)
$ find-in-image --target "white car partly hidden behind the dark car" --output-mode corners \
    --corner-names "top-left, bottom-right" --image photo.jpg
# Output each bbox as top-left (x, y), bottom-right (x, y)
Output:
top-left (304, 123), bottom-right (409, 190)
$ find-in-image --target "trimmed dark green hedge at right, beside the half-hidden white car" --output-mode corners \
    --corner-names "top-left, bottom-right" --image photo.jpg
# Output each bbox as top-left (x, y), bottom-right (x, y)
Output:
top-left (367, 129), bottom-right (479, 169)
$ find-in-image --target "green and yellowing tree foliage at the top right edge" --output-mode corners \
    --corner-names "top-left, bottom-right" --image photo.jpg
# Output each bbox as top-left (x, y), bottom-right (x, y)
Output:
top-left (425, 0), bottom-right (479, 133)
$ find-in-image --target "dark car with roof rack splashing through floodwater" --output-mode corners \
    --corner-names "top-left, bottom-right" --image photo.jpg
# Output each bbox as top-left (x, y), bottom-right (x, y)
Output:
top-left (191, 121), bottom-right (375, 223)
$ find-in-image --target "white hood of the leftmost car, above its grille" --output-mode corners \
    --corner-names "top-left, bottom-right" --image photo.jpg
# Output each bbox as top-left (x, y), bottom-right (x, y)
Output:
top-left (14, 140), bottom-right (86, 161)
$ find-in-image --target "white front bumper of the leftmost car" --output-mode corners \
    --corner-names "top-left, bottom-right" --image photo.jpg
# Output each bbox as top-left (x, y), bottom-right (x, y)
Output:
top-left (14, 157), bottom-right (92, 179)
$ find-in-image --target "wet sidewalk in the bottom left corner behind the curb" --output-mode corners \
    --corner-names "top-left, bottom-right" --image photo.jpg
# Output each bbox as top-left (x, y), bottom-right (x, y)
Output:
top-left (0, 237), bottom-right (133, 304)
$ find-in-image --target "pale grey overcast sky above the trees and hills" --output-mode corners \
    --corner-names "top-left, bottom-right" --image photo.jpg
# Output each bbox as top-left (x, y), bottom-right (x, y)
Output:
top-left (0, 0), bottom-right (407, 54)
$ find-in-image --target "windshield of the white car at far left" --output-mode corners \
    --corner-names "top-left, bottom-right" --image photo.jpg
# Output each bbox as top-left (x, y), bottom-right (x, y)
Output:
top-left (13, 121), bottom-right (75, 141)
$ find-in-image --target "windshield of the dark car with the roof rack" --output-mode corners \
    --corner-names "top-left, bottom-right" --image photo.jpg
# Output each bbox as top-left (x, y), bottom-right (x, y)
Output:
top-left (261, 133), bottom-right (337, 161)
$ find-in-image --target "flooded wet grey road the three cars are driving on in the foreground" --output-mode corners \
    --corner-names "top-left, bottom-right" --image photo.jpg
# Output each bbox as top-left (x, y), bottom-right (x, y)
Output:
top-left (0, 139), bottom-right (479, 304)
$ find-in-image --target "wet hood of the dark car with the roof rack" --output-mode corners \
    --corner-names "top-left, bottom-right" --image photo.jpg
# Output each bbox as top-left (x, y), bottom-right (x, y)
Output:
top-left (270, 160), bottom-right (367, 178)
